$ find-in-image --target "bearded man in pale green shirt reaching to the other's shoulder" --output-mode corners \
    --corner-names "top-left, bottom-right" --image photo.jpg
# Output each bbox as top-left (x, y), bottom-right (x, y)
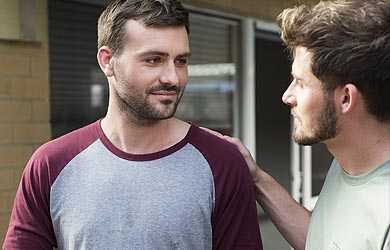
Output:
top-left (204, 0), bottom-right (390, 250)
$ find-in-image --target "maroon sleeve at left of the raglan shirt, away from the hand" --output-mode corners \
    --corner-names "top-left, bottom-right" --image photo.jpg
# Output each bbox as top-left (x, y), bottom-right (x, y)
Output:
top-left (3, 121), bottom-right (100, 250)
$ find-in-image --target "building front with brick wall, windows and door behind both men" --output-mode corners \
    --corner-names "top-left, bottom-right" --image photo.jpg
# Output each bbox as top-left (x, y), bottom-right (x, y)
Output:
top-left (0, 0), bottom-right (330, 249)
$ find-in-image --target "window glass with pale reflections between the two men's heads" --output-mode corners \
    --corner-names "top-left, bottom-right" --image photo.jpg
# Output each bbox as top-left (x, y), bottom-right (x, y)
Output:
top-left (176, 13), bottom-right (238, 135)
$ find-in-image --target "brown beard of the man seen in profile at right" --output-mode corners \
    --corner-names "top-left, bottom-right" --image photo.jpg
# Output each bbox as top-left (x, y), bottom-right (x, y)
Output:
top-left (293, 94), bottom-right (340, 146)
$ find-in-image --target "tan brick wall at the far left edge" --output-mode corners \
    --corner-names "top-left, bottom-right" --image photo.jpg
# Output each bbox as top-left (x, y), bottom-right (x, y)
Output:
top-left (0, 0), bottom-right (51, 246)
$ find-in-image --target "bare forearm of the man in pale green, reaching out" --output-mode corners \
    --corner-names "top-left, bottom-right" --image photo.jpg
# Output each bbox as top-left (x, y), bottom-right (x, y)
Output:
top-left (254, 168), bottom-right (311, 250)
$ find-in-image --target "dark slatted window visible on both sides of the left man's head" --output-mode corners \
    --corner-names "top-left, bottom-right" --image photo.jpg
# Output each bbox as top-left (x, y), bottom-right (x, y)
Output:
top-left (48, 0), bottom-right (238, 137)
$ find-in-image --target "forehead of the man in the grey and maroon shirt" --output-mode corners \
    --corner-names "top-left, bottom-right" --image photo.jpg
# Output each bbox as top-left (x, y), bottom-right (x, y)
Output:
top-left (124, 20), bottom-right (189, 54)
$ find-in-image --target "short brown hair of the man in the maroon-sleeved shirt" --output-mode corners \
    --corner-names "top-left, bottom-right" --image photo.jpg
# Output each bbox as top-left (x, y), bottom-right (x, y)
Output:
top-left (98, 0), bottom-right (189, 55)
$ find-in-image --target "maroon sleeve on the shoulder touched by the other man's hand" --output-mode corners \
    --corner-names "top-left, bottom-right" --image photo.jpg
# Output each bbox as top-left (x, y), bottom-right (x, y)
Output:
top-left (188, 126), bottom-right (263, 250)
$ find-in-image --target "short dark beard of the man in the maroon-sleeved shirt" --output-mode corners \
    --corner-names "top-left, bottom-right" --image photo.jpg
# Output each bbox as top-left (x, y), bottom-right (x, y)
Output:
top-left (113, 65), bottom-right (183, 126)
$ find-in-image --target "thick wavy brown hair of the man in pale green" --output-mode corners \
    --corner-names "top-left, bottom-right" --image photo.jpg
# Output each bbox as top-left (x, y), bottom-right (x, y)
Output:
top-left (277, 0), bottom-right (390, 121)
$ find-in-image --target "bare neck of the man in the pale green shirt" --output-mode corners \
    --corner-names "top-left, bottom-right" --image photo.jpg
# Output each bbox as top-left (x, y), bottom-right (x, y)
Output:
top-left (325, 119), bottom-right (390, 176)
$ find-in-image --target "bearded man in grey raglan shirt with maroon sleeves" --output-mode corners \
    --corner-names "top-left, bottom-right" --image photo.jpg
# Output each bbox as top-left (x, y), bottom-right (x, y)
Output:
top-left (3, 0), bottom-right (262, 250)
